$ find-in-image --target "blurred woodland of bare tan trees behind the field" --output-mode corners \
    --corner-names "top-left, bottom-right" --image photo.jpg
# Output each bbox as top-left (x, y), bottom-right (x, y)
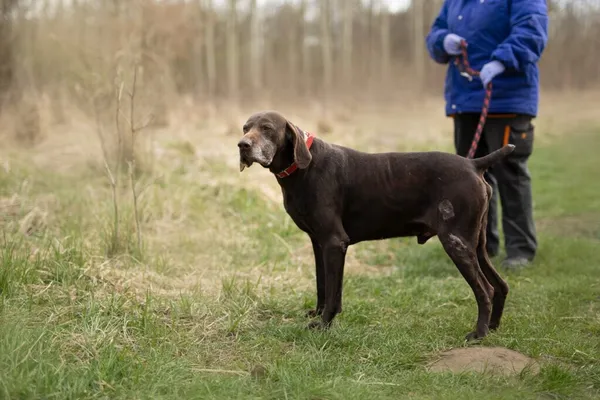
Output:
top-left (0, 0), bottom-right (600, 142)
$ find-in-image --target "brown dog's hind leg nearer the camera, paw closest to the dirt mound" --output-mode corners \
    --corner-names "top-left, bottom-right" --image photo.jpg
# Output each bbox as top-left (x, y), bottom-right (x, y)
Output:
top-left (438, 233), bottom-right (494, 341)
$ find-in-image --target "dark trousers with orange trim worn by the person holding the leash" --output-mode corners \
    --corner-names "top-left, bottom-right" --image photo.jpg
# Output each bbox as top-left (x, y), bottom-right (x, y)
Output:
top-left (454, 114), bottom-right (537, 260)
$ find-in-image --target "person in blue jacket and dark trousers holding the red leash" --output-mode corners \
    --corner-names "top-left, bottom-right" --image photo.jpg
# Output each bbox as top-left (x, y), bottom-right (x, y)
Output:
top-left (426, 0), bottom-right (548, 268)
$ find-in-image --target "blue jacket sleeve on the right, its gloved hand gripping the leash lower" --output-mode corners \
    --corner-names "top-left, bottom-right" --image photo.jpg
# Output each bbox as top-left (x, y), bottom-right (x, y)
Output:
top-left (492, 0), bottom-right (548, 71)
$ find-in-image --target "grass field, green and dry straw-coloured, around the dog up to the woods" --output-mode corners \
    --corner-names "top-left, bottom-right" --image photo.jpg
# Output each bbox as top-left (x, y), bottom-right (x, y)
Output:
top-left (0, 95), bottom-right (600, 399)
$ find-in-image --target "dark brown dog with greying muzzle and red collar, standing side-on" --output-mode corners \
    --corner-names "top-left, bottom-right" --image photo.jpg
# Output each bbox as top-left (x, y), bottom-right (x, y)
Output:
top-left (238, 111), bottom-right (514, 340)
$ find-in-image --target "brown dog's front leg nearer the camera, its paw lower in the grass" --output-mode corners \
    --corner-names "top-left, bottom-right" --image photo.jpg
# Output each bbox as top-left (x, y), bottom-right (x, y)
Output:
top-left (309, 235), bottom-right (349, 328)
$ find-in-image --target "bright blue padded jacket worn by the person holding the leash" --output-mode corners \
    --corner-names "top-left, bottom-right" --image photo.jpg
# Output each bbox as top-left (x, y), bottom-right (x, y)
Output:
top-left (427, 0), bottom-right (548, 116)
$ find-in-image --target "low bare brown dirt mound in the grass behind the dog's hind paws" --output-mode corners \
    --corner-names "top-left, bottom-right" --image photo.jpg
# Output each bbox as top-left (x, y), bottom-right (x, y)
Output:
top-left (428, 347), bottom-right (539, 375)
